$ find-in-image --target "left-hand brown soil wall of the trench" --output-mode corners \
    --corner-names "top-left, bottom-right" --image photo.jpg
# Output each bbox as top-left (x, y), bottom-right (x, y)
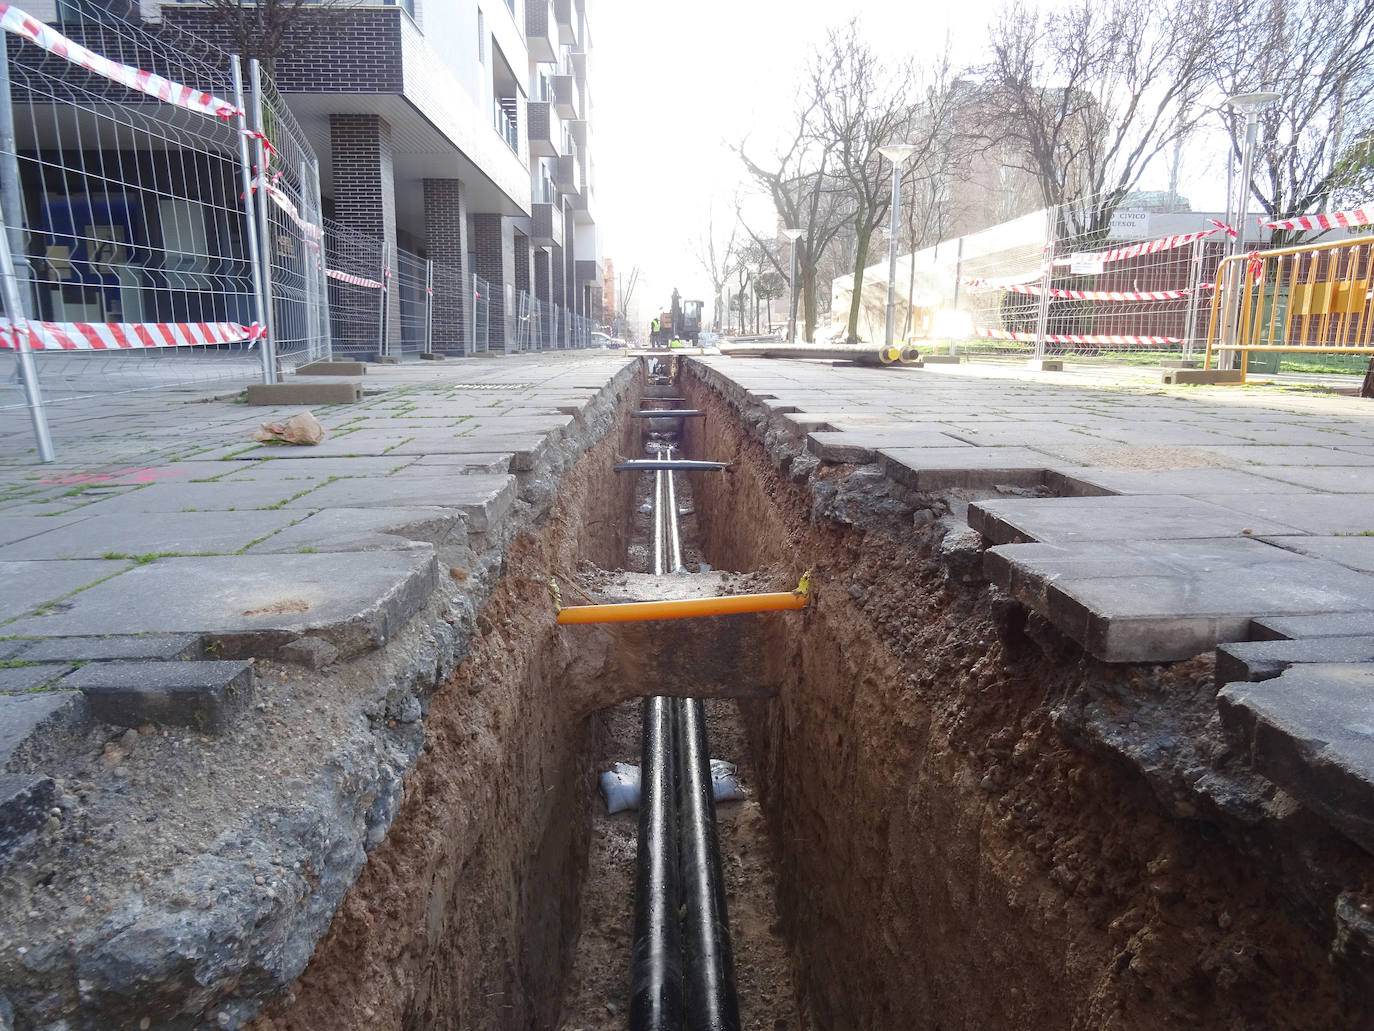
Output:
top-left (253, 376), bottom-right (638, 1031)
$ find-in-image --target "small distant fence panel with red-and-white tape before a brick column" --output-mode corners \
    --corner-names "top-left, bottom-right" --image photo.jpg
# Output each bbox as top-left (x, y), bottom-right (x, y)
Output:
top-left (323, 219), bottom-right (386, 362)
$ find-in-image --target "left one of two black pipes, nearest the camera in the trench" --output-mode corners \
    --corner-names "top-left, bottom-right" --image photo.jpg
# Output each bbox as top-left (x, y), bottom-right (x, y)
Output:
top-left (629, 697), bottom-right (683, 1031)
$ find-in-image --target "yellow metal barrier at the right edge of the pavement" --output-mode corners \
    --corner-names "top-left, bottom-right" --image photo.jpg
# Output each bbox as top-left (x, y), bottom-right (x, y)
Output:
top-left (1204, 239), bottom-right (1374, 382)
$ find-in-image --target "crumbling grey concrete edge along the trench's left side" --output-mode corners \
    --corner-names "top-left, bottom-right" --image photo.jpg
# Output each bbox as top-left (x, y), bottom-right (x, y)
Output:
top-left (5, 362), bottom-right (640, 1027)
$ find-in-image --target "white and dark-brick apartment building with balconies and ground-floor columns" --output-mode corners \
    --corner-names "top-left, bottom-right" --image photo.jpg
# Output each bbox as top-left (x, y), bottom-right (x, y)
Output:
top-left (20, 0), bottom-right (602, 353)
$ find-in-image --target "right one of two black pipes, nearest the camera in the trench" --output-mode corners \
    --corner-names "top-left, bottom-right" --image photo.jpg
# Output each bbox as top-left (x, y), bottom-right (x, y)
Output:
top-left (675, 698), bottom-right (739, 1031)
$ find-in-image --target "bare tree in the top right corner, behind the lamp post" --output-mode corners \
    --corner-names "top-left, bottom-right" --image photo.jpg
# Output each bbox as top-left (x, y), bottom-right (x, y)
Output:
top-left (1215, 0), bottom-right (1374, 245)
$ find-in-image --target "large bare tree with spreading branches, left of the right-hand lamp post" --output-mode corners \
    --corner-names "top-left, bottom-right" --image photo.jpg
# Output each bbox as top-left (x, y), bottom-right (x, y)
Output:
top-left (984, 0), bottom-right (1214, 241)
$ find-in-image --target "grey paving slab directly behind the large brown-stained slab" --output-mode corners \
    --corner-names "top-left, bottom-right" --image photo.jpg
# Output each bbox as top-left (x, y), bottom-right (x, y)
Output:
top-left (249, 507), bottom-right (467, 554)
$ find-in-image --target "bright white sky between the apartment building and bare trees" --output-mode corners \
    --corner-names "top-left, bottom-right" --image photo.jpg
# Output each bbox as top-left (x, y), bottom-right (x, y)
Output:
top-left (589, 0), bottom-right (1224, 318)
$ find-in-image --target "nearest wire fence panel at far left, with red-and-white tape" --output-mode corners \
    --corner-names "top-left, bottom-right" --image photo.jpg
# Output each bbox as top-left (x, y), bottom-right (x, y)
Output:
top-left (0, 7), bottom-right (264, 408)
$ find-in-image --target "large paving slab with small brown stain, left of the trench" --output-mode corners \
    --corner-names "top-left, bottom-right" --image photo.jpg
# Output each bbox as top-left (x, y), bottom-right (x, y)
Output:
top-left (5, 551), bottom-right (438, 656)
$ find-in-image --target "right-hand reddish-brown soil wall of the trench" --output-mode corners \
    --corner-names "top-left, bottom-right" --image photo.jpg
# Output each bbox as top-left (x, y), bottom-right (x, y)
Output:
top-left (682, 363), bottom-right (1374, 1031)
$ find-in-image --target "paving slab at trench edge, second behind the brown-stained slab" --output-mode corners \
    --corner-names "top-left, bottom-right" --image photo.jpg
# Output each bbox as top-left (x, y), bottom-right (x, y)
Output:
top-left (286, 472), bottom-right (515, 532)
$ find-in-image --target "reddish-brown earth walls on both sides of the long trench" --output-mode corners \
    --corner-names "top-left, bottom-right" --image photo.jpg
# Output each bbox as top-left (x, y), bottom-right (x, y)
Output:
top-left (256, 363), bottom-right (1374, 1031)
